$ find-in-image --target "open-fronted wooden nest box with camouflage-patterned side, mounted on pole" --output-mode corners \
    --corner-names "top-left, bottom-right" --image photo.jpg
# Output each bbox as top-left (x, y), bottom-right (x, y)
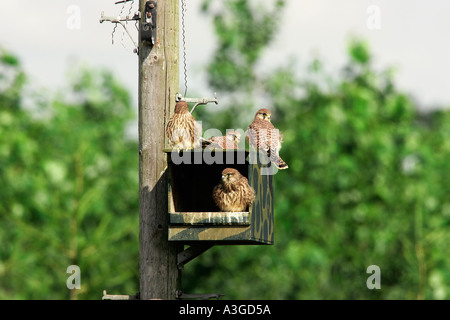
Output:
top-left (164, 150), bottom-right (274, 245)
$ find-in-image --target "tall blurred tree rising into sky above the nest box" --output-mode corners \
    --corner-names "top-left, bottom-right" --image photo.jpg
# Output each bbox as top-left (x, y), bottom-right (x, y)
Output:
top-left (196, 0), bottom-right (285, 132)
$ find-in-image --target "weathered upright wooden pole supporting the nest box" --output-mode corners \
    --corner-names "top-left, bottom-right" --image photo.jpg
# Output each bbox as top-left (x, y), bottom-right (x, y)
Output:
top-left (139, 0), bottom-right (182, 300)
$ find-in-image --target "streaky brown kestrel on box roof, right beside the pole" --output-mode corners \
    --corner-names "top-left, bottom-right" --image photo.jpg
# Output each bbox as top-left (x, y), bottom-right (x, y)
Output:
top-left (166, 101), bottom-right (201, 150)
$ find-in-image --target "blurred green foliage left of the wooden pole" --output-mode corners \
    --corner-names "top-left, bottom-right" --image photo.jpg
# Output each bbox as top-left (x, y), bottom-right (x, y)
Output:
top-left (0, 50), bottom-right (138, 299)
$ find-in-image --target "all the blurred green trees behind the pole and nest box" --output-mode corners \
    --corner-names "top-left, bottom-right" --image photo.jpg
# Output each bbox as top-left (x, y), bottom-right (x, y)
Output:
top-left (0, 0), bottom-right (450, 299)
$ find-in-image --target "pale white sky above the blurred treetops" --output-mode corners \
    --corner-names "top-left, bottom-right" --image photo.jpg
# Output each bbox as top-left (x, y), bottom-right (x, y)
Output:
top-left (0, 0), bottom-right (450, 110)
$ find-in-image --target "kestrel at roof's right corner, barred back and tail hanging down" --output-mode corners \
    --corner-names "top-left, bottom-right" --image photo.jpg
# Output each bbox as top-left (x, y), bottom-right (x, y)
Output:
top-left (246, 109), bottom-right (288, 169)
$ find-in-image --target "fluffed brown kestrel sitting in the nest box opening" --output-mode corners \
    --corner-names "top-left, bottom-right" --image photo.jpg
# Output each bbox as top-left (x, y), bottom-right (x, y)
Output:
top-left (213, 168), bottom-right (255, 212)
